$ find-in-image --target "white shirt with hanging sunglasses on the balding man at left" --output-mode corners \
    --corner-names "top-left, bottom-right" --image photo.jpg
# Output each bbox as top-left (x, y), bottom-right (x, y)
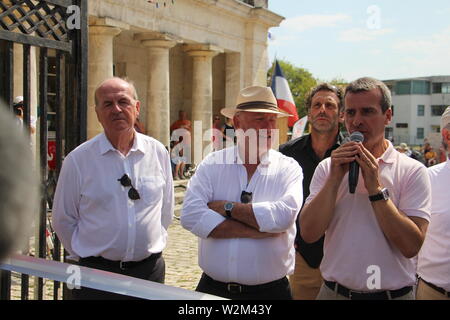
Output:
top-left (53, 133), bottom-right (174, 261)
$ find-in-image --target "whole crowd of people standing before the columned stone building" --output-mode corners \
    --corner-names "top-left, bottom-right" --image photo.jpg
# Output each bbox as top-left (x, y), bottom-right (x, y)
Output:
top-left (2, 78), bottom-right (450, 300)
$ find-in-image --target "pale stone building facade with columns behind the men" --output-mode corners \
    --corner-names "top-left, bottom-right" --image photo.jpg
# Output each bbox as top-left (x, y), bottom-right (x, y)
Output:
top-left (88, 0), bottom-right (283, 146)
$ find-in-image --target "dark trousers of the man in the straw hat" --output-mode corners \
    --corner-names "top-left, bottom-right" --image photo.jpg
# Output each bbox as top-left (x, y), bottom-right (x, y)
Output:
top-left (195, 273), bottom-right (292, 300)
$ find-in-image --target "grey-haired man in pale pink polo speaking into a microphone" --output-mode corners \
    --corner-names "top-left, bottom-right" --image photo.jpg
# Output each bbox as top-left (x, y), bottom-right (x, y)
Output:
top-left (300, 78), bottom-right (430, 300)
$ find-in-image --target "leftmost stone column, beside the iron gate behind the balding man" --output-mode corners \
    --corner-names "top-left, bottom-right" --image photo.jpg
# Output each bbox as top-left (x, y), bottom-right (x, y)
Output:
top-left (87, 25), bottom-right (121, 139)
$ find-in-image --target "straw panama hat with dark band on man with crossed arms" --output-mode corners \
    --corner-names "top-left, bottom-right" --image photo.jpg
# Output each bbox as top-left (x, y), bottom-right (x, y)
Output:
top-left (220, 86), bottom-right (291, 119)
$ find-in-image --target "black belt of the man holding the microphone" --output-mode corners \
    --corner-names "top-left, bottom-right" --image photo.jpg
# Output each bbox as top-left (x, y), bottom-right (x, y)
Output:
top-left (324, 280), bottom-right (412, 300)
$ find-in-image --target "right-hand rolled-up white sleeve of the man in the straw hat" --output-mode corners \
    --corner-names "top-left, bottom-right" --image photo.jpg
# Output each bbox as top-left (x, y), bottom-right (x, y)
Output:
top-left (252, 161), bottom-right (303, 233)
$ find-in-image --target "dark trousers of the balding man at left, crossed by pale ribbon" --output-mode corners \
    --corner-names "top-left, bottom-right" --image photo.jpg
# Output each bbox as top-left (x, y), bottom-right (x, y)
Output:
top-left (72, 254), bottom-right (166, 300)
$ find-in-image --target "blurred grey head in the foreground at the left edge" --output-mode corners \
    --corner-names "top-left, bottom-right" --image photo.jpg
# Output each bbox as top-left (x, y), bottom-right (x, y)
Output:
top-left (0, 102), bottom-right (39, 261)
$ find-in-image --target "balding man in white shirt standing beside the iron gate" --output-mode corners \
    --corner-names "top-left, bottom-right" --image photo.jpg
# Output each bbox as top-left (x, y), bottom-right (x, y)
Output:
top-left (53, 78), bottom-right (174, 299)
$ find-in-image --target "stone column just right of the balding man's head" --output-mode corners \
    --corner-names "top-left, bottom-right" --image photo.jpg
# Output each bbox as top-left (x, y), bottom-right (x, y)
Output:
top-left (135, 33), bottom-right (177, 147)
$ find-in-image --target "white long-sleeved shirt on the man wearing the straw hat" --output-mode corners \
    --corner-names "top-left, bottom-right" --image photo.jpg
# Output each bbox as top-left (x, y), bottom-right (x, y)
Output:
top-left (181, 147), bottom-right (303, 285)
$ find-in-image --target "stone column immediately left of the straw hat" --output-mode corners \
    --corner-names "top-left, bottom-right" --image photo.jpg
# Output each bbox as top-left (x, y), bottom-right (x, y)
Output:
top-left (185, 45), bottom-right (223, 164)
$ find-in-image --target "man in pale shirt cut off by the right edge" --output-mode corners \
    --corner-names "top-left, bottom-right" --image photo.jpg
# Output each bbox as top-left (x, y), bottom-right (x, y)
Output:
top-left (416, 107), bottom-right (450, 300)
